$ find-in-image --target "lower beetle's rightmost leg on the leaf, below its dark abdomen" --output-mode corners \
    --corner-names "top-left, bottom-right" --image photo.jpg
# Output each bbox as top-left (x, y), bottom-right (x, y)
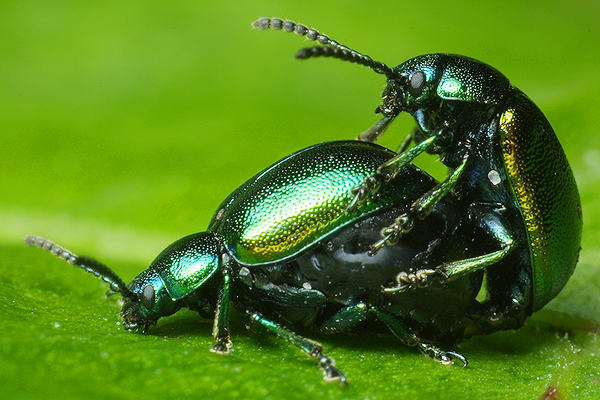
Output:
top-left (370, 307), bottom-right (468, 368)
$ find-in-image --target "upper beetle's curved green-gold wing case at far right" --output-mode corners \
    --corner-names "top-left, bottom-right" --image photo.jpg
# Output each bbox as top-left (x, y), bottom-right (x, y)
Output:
top-left (500, 89), bottom-right (582, 311)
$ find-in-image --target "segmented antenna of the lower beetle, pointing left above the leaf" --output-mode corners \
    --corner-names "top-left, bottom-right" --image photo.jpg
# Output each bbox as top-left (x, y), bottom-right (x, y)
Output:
top-left (25, 235), bottom-right (135, 298)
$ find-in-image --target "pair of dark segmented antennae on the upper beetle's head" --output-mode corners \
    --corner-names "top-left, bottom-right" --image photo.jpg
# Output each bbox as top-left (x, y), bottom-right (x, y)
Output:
top-left (252, 18), bottom-right (402, 79)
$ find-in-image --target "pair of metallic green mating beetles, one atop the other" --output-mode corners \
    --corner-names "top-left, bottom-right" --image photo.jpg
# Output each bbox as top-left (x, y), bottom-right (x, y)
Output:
top-left (27, 19), bottom-right (581, 382)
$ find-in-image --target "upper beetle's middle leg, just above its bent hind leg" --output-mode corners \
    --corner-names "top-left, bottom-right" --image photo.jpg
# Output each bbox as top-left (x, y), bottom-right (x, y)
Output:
top-left (370, 155), bottom-right (469, 254)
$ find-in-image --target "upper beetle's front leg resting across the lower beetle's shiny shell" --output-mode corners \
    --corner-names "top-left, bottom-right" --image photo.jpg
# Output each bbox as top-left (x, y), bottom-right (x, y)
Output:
top-left (346, 136), bottom-right (438, 212)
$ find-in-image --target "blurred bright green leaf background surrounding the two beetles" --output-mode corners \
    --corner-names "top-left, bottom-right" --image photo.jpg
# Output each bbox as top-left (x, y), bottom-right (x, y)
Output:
top-left (0, 0), bottom-right (600, 399)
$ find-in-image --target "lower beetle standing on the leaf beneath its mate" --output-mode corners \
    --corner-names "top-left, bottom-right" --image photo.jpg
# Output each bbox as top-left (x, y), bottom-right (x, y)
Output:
top-left (25, 141), bottom-right (493, 383)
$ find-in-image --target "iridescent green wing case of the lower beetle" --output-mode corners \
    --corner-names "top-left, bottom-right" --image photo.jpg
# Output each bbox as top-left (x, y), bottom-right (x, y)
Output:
top-left (209, 141), bottom-right (434, 265)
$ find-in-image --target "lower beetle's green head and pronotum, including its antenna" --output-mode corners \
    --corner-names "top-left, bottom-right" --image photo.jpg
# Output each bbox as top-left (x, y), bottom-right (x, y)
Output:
top-left (25, 232), bottom-right (221, 332)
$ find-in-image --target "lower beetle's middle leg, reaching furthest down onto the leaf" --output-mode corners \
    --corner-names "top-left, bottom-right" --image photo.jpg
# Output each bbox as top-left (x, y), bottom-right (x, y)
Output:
top-left (247, 311), bottom-right (346, 385)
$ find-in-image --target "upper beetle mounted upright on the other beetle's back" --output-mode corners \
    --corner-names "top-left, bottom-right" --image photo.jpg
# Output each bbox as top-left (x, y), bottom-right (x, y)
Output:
top-left (253, 18), bottom-right (582, 332)
